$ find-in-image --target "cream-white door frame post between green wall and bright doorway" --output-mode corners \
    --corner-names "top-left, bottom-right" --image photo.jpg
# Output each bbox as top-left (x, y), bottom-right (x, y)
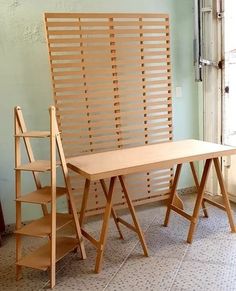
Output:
top-left (199, 0), bottom-right (224, 195)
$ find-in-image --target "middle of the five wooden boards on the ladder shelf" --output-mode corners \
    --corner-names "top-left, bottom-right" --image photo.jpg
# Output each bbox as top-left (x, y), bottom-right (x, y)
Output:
top-left (16, 186), bottom-right (67, 204)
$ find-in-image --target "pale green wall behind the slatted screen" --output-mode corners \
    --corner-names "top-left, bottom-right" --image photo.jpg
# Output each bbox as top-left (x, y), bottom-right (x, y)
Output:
top-left (0, 0), bottom-right (198, 223)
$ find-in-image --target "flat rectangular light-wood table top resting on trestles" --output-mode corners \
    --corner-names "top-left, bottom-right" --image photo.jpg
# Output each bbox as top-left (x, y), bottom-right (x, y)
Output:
top-left (67, 139), bottom-right (236, 180)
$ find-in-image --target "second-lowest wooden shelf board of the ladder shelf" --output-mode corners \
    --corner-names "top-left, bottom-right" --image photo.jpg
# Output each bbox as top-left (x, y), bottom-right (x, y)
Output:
top-left (15, 213), bottom-right (73, 237)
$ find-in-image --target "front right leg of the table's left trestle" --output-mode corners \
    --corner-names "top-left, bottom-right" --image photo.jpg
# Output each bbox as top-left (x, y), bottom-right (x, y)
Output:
top-left (119, 176), bottom-right (148, 257)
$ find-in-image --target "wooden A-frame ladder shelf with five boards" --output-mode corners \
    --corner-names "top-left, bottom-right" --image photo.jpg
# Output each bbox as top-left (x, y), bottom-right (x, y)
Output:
top-left (15, 107), bottom-right (86, 288)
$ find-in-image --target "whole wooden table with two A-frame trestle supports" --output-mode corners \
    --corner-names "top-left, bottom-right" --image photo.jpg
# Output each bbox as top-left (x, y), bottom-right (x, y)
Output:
top-left (67, 140), bottom-right (236, 272)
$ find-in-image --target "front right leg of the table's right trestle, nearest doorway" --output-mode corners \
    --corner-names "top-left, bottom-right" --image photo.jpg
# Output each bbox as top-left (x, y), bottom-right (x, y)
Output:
top-left (213, 158), bottom-right (236, 232)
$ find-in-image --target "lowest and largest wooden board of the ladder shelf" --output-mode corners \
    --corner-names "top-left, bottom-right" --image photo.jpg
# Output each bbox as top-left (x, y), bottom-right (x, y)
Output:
top-left (16, 237), bottom-right (78, 271)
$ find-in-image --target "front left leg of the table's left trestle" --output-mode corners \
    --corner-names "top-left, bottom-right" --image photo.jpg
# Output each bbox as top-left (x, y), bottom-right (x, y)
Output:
top-left (95, 177), bottom-right (116, 273)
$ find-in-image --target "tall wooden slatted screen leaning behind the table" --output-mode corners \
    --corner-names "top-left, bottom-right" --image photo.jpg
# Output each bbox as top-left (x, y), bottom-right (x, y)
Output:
top-left (45, 13), bottom-right (173, 213)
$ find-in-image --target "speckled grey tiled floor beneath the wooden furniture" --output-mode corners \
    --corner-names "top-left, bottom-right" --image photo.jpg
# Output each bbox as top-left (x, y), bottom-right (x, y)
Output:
top-left (0, 195), bottom-right (236, 291)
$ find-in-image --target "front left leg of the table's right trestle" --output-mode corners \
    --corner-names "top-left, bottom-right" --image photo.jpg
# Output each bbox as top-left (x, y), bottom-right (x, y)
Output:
top-left (187, 159), bottom-right (212, 243)
